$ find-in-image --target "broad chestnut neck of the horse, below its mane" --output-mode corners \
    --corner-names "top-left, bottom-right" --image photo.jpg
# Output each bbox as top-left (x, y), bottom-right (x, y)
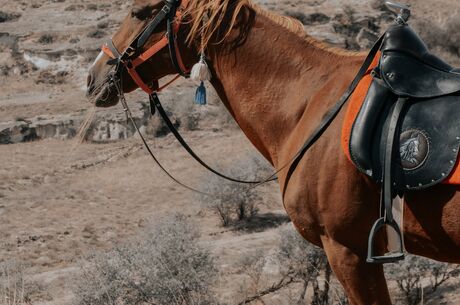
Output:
top-left (210, 11), bottom-right (360, 165)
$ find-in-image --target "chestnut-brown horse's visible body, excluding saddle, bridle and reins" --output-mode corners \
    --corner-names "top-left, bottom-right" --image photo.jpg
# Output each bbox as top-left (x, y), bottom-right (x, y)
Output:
top-left (88, 0), bottom-right (460, 305)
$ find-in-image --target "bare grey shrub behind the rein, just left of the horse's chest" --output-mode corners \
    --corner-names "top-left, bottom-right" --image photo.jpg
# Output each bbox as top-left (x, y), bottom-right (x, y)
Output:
top-left (198, 156), bottom-right (270, 227)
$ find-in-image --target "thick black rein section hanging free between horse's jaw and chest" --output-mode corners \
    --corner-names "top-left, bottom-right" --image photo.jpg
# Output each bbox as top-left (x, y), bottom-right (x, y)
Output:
top-left (150, 93), bottom-right (277, 184)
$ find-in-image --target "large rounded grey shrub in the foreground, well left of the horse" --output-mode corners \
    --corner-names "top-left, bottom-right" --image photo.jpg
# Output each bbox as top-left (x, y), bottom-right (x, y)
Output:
top-left (75, 215), bottom-right (217, 305)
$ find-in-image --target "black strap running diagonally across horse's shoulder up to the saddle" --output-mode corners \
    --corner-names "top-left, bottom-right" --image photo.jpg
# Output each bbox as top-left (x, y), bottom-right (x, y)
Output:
top-left (283, 34), bottom-right (385, 193)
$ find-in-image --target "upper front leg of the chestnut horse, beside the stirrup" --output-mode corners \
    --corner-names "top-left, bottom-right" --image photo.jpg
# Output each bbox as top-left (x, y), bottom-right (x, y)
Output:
top-left (321, 236), bottom-right (391, 305)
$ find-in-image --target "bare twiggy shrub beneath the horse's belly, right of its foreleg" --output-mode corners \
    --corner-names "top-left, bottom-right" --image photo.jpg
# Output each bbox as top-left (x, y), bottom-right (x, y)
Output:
top-left (386, 255), bottom-right (460, 305)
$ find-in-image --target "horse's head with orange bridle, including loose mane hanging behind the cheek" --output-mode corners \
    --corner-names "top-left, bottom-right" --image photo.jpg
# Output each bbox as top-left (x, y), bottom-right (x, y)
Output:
top-left (87, 0), bottom-right (254, 107)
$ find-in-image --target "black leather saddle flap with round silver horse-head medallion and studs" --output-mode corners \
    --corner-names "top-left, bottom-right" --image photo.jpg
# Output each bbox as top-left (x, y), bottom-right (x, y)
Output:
top-left (380, 95), bottom-right (460, 190)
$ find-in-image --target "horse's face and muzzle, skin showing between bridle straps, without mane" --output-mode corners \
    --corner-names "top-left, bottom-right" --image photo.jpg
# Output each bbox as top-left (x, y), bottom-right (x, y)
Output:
top-left (87, 0), bottom-right (198, 107)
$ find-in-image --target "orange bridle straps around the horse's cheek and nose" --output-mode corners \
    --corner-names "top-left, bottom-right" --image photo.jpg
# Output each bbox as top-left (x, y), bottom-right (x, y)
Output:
top-left (102, 0), bottom-right (190, 95)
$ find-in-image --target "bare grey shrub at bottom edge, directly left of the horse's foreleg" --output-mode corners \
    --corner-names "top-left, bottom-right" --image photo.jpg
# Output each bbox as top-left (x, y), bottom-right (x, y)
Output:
top-left (239, 227), bottom-right (347, 305)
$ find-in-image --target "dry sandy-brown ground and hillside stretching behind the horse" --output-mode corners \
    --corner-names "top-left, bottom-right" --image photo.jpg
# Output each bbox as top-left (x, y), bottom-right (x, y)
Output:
top-left (0, 0), bottom-right (460, 305)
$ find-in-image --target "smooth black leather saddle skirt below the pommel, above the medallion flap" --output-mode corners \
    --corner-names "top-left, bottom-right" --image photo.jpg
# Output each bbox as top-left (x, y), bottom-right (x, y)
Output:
top-left (380, 51), bottom-right (460, 98)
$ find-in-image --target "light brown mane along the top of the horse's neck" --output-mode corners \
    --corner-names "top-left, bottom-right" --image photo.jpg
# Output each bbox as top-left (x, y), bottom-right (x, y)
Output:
top-left (185, 0), bottom-right (361, 56)
